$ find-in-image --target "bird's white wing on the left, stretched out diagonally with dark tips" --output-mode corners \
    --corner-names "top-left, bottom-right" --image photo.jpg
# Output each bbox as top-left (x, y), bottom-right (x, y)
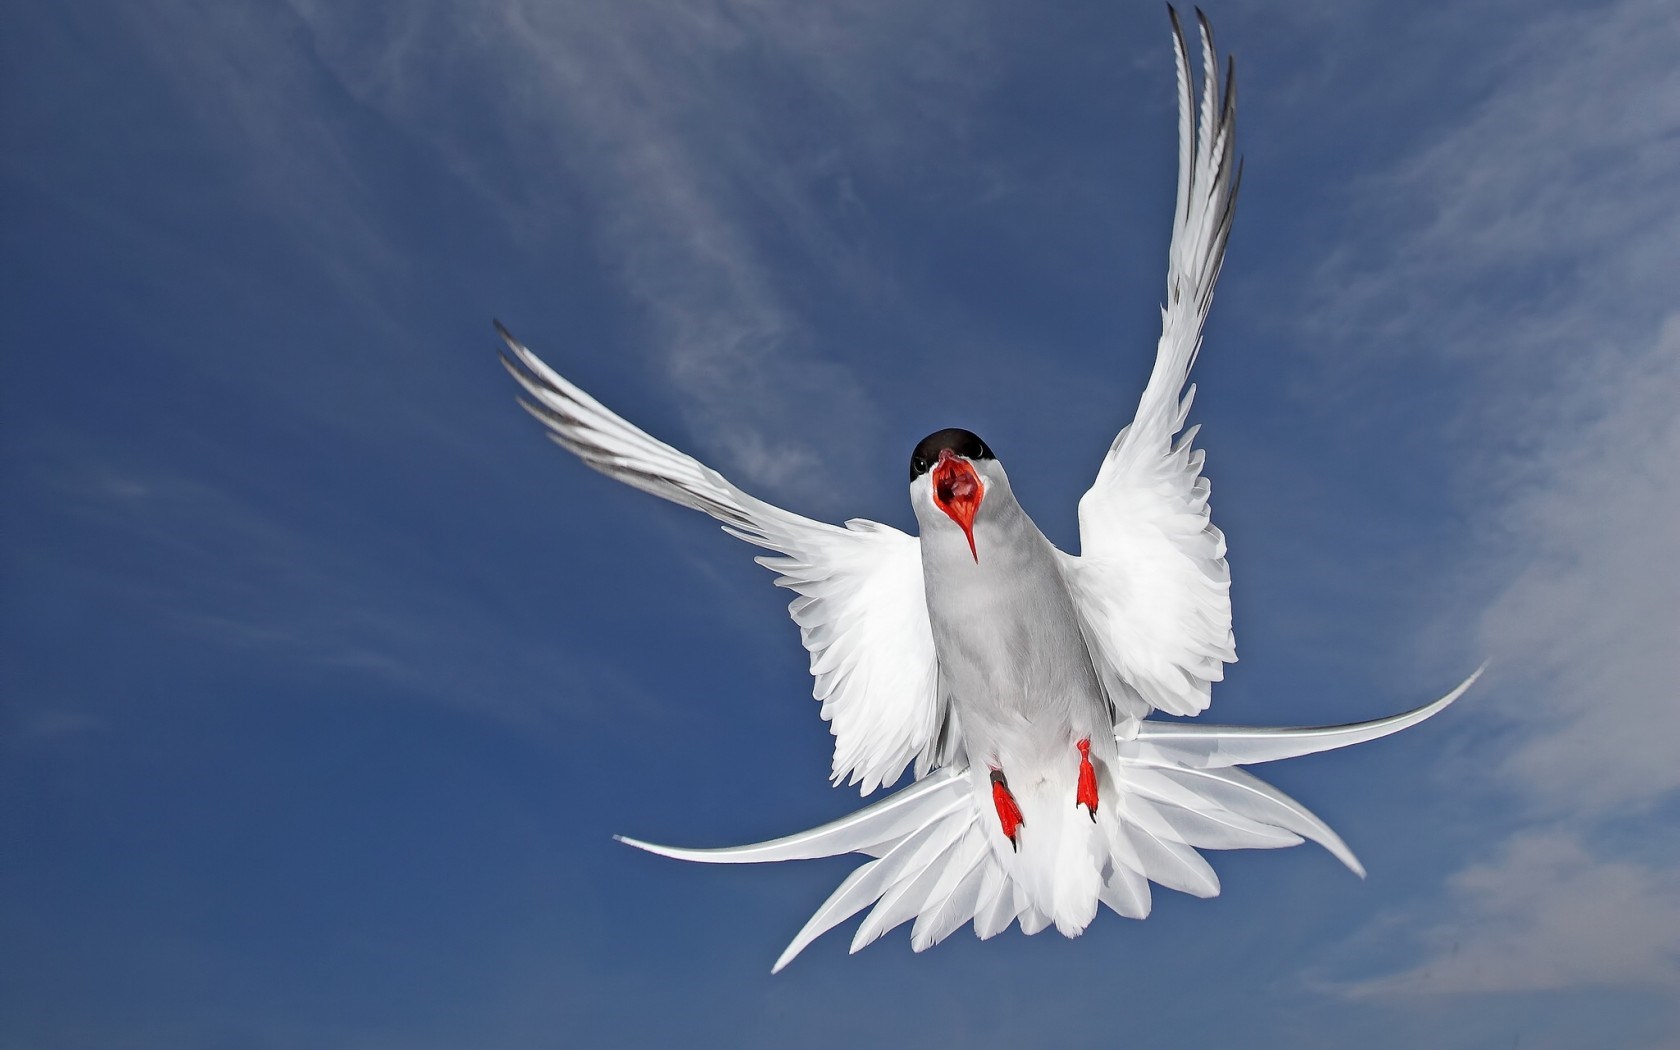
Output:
top-left (496, 324), bottom-right (948, 795)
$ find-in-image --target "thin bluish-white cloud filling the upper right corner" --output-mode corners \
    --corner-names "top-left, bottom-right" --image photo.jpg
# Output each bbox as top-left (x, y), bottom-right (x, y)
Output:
top-left (1312, 0), bottom-right (1680, 376)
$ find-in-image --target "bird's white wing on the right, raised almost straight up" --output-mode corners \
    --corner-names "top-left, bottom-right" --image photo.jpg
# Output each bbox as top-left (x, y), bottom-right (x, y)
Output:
top-left (1063, 12), bottom-right (1242, 717)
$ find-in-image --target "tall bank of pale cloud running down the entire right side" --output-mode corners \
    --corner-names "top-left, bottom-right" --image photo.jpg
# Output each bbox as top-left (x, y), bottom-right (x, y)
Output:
top-left (1276, 0), bottom-right (1680, 995)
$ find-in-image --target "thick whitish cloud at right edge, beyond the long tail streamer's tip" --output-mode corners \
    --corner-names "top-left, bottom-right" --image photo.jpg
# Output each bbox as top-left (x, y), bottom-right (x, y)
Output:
top-left (1480, 314), bottom-right (1680, 815)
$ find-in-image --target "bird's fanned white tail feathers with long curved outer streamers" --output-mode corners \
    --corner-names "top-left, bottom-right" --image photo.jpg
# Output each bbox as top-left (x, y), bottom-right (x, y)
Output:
top-left (618, 669), bottom-right (1482, 973)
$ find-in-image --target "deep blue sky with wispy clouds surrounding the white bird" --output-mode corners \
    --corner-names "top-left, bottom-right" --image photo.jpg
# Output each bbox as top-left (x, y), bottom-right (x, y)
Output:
top-left (0, 0), bottom-right (1680, 1050)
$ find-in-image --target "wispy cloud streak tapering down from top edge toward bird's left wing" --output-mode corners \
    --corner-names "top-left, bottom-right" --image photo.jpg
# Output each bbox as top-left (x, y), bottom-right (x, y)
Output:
top-left (268, 0), bottom-right (1007, 496)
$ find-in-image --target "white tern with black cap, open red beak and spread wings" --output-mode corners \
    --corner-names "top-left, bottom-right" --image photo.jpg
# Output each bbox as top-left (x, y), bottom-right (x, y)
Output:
top-left (497, 8), bottom-right (1480, 969)
